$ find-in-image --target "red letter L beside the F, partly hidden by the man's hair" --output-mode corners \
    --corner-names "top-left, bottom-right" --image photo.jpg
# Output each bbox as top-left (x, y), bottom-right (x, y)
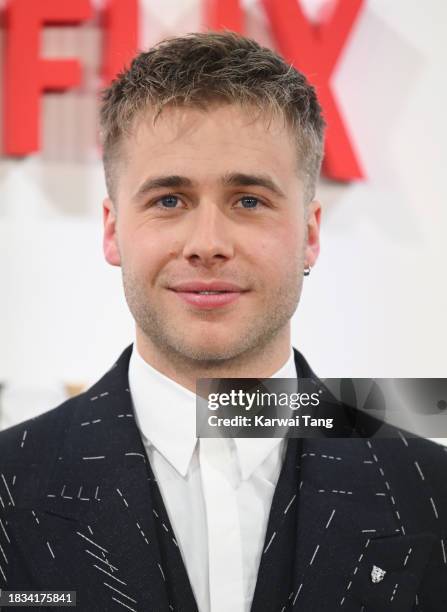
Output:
top-left (103, 0), bottom-right (139, 86)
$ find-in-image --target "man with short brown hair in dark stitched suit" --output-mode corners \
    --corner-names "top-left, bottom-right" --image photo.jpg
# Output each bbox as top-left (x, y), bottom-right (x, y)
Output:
top-left (0, 33), bottom-right (447, 612)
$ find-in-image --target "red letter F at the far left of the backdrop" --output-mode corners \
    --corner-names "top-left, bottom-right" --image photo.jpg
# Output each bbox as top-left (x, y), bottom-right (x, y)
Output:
top-left (3, 0), bottom-right (92, 155)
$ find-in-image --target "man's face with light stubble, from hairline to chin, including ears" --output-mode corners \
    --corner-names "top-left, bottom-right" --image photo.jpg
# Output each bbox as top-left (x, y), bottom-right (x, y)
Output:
top-left (104, 105), bottom-right (320, 363)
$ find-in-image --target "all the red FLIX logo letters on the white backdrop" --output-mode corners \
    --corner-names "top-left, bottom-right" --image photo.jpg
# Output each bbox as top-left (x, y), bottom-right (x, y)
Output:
top-left (3, 0), bottom-right (363, 181)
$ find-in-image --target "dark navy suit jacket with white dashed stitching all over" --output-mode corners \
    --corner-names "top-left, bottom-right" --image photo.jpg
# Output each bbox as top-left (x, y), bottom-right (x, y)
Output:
top-left (0, 347), bottom-right (447, 612)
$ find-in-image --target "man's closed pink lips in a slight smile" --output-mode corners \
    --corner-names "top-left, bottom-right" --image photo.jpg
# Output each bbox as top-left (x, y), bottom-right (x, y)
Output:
top-left (170, 281), bottom-right (248, 310)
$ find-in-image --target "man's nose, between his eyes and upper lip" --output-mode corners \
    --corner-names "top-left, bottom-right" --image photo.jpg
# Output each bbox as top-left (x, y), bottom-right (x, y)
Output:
top-left (183, 202), bottom-right (234, 266)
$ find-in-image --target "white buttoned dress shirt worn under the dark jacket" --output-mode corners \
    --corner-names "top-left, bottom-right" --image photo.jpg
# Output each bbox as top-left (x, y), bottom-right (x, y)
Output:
top-left (129, 345), bottom-right (296, 612)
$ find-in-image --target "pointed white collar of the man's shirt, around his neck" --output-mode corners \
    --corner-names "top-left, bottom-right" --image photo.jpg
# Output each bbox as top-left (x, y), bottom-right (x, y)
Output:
top-left (129, 344), bottom-right (297, 480)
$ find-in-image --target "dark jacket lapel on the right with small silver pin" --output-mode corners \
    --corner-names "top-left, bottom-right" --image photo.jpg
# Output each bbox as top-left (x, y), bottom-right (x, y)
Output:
top-left (286, 439), bottom-right (435, 612)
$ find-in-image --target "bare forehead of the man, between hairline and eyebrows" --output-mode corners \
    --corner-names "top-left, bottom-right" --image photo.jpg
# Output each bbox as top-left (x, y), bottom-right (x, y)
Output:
top-left (114, 104), bottom-right (299, 198)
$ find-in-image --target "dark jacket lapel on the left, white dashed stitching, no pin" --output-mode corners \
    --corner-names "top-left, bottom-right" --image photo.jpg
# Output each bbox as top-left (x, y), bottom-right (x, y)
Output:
top-left (9, 347), bottom-right (196, 611)
